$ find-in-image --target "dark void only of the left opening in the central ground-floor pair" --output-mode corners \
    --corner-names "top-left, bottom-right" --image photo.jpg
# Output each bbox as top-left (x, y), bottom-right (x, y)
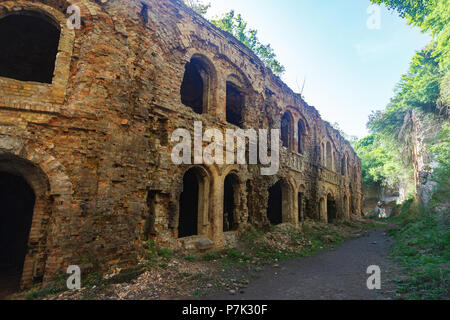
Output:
top-left (178, 170), bottom-right (199, 238)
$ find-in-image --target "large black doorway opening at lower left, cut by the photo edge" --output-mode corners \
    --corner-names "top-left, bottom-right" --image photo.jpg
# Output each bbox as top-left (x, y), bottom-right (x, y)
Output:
top-left (0, 172), bottom-right (35, 298)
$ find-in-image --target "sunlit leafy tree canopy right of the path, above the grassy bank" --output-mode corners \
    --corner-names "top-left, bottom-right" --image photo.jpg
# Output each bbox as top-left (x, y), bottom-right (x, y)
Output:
top-left (354, 0), bottom-right (450, 195)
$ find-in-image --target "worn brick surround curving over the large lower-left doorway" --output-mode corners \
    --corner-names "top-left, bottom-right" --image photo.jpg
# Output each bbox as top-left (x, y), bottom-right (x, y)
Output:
top-left (0, 135), bottom-right (73, 287)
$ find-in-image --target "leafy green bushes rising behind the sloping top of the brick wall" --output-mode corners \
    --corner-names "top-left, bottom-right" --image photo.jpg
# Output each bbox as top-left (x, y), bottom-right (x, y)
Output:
top-left (211, 10), bottom-right (285, 75)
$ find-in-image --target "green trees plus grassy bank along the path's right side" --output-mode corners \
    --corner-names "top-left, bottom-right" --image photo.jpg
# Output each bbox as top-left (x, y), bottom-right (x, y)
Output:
top-left (354, 0), bottom-right (450, 299)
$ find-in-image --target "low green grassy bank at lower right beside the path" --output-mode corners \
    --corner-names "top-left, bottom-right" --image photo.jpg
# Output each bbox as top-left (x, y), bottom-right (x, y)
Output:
top-left (389, 199), bottom-right (450, 300)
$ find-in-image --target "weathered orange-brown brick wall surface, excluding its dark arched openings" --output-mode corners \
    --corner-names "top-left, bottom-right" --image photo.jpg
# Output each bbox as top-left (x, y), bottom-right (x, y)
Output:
top-left (0, 0), bottom-right (362, 283)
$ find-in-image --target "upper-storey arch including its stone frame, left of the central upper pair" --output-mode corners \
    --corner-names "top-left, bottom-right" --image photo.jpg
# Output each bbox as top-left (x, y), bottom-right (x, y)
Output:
top-left (180, 53), bottom-right (217, 114)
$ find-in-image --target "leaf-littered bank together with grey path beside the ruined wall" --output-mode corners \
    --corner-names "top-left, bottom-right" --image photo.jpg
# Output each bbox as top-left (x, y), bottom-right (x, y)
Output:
top-left (8, 220), bottom-right (395, 300)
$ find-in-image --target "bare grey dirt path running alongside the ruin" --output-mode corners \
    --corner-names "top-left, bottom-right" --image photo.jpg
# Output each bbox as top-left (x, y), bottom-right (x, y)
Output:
top-left (202, 229), bottom-right (396, 300)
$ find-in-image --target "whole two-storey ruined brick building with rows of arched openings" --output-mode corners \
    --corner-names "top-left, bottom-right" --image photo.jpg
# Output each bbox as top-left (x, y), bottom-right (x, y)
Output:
top-left (0, 0), bottom-right (362, 292)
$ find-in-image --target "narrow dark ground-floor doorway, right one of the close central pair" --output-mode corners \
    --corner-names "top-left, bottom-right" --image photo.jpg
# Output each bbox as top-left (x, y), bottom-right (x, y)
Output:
top-left (223, 174), bottom-right (239, 232)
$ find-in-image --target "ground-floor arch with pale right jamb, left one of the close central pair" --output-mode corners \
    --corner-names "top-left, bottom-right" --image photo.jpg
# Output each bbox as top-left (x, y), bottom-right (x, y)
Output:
top-left (175, 166), bottom-right (211, 238)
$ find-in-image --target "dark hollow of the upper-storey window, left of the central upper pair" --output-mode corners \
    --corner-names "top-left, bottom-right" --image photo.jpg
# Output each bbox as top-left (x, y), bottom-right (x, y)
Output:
top-left (180, 58), bottom-right (209, 114)
